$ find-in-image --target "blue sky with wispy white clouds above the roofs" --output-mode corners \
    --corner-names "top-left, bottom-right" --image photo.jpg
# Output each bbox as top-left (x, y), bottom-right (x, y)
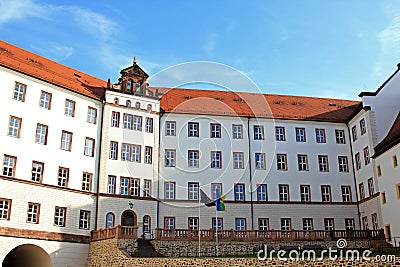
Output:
top-left (0, 0), bottom-right (400, 99)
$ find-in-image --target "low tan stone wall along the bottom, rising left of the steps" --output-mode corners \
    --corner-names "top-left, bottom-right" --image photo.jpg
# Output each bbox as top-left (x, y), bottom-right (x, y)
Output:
top-left (87, 238), bottom-right (400, 267)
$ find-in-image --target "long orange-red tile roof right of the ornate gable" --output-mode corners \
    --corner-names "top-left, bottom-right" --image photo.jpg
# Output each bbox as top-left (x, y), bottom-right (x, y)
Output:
top-left (159, 88), bottom-right (362, 122)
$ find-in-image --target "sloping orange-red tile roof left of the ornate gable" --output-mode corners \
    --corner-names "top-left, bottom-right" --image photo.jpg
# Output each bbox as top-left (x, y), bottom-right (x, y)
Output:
top-left (0, 40), bottom-right (107, 99)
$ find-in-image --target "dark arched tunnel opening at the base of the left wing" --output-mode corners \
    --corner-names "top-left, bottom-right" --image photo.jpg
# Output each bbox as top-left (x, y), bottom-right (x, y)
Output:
top-left (2, 244), bottom-right (53, 267)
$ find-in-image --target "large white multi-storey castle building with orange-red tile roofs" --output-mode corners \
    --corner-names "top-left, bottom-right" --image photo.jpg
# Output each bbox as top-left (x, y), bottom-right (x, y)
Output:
top-left (0, 41), bottom-right (400, 266)
